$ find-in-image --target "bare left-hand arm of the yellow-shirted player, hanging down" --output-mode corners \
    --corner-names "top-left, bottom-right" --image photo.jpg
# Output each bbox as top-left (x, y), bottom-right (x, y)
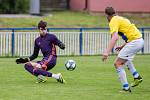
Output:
top-left (102, 32), bottom-right (119, 61)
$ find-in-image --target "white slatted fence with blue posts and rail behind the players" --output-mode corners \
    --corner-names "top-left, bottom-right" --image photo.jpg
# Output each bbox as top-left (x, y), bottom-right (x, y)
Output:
top-left (0, 28), bottom-right (150, 57)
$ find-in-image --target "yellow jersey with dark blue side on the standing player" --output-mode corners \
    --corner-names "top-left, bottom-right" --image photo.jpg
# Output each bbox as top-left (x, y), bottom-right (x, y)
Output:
top-left (109, 16), bottom-right (142, 42)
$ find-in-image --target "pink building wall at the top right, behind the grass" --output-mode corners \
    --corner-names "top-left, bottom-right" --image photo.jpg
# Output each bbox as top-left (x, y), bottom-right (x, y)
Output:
top-left (70, 0), bottom-right (150, 12)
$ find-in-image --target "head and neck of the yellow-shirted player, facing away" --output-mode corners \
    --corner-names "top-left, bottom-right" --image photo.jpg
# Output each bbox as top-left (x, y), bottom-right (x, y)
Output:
top-left (105, 7), bottom-right (116, 21)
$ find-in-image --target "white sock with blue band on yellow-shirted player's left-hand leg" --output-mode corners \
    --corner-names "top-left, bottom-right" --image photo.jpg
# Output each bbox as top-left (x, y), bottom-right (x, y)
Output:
top-left (116, 67), bottom-right (129, 90)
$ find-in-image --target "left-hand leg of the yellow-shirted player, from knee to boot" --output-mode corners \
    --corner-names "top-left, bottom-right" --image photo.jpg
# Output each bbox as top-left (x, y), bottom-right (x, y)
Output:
top-left (114, 58), bottom-right (131, 92)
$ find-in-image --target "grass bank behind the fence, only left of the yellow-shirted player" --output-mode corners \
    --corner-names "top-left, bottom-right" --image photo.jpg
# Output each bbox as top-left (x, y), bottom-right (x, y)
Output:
top-left (0, 11), bottom-right (104, 27)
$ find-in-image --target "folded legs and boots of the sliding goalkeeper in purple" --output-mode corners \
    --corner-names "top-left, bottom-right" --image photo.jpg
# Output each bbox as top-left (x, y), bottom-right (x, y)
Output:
top-left (24, 58), bottom-right (65, 83)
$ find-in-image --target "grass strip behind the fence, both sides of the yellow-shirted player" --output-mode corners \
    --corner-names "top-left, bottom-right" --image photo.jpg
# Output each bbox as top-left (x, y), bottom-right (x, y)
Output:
top-left (0, 11), bottom-right (150, 28)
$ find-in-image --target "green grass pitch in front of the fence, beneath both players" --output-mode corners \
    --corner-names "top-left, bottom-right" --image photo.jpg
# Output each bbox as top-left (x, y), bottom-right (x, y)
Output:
top-left (0, 55), bottom-right (150, 100)
